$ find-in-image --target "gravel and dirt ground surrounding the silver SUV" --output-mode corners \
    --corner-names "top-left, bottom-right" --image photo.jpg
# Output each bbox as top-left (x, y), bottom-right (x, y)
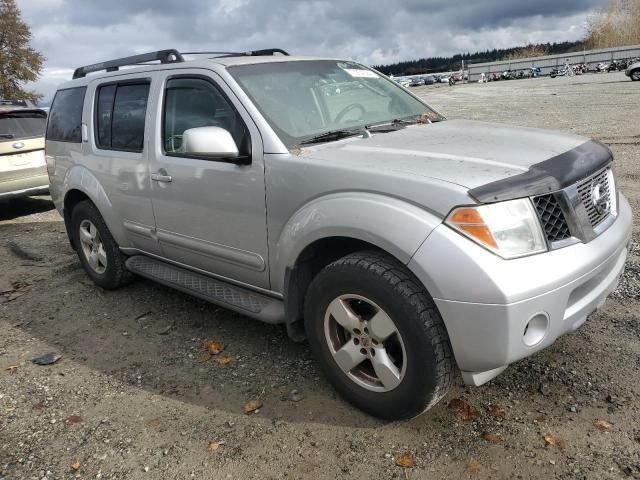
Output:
top-left (0, 73), bottom-right (640, 480)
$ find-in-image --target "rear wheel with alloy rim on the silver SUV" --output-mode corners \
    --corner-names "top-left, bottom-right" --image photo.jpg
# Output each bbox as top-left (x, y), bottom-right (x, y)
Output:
top-left (71, 200), bottom-right (133, 290)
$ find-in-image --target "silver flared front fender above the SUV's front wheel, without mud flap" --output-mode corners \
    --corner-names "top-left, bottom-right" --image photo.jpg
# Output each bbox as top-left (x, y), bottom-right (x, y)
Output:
top-left (271, 192), bottom-right (442, 292)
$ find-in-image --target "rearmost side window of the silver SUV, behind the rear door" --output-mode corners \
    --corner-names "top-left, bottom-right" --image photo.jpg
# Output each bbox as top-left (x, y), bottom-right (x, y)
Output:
top-left (46, 87), bottom-right (87, 143)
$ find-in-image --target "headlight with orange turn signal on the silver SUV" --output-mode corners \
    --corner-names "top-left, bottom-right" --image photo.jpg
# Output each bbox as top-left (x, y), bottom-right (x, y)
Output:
top-left (445, 198), bottom-right (547, 258)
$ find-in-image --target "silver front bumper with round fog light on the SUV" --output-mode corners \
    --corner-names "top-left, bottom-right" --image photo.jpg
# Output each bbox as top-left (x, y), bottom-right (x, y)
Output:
top-left (409, 195), bottom-right (632, 385)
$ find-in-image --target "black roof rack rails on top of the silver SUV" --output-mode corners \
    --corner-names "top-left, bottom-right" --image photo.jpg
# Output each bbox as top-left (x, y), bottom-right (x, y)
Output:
top-left (73, 48), bottom-right (289, 79)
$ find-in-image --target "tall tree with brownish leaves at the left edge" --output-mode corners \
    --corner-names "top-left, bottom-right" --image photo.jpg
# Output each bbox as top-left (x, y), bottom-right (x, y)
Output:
top-left (0, 0), bottom-right (44, 101)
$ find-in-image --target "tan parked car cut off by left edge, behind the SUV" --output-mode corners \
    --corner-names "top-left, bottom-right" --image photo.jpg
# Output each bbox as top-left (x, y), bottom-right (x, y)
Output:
top-left (0, 99), bottom-right (49, 200)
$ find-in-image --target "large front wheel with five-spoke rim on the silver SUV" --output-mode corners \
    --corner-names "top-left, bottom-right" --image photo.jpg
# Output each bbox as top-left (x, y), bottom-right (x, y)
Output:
top-left (305, 251), bottom-right (454, 420)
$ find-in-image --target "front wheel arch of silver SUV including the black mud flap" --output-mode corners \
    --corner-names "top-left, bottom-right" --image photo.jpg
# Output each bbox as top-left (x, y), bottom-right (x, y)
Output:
top-left (271, 193), bottom-right (442, 341)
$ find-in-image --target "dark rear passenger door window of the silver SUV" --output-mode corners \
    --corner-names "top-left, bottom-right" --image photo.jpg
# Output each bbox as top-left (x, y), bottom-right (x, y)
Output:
top-left (95, 83), bottom-right (149, 152)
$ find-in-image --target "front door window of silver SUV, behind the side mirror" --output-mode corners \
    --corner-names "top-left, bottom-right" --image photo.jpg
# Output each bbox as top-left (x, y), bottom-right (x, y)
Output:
top-left (163, 78), bottom-right (251, 155)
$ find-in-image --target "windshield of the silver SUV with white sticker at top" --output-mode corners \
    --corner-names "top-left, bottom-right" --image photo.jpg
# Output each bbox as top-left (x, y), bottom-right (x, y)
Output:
top-left (229, 60), bottom-right (444, 148)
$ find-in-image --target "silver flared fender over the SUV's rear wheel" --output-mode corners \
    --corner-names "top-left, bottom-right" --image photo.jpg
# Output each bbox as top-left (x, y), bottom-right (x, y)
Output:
top-left (62, 164), bottom-right (128, 246)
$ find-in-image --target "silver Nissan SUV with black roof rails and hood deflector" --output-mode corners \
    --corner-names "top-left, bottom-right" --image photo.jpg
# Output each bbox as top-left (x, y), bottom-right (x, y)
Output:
top-left (46, 49), bottom-right (632, 419)
